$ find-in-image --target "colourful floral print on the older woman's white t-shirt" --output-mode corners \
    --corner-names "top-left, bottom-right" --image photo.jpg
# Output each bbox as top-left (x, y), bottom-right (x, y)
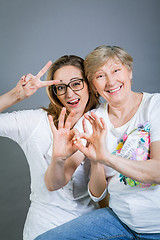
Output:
top-left (112, 122), bottom-right (155, 188)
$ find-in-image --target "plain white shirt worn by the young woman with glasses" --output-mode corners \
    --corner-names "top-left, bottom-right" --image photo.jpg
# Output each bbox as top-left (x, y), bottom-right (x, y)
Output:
top-left (0, 109), bottom-right (97, 240)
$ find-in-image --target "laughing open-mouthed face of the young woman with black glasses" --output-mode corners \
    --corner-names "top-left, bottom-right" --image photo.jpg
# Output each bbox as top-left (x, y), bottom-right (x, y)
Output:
top-left (54, 66), bottom-right (89, 116)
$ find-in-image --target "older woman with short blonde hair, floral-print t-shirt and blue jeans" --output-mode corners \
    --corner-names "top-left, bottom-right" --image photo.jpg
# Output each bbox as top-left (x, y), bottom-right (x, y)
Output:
top-left (38, 46), bottom-right (160, 240)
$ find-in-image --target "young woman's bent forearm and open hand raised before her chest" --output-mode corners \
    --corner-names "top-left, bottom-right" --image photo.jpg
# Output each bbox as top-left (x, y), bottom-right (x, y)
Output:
top-left (45, 108), bottom-right (84, 191)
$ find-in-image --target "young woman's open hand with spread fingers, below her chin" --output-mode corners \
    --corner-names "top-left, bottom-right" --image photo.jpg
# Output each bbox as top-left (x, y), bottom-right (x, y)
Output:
top-left (48, 108), bottom-right (78, 161)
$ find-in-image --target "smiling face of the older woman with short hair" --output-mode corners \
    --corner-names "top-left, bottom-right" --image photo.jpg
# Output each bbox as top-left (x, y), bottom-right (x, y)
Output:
top-left (93, 59), bottom-right (132, 105)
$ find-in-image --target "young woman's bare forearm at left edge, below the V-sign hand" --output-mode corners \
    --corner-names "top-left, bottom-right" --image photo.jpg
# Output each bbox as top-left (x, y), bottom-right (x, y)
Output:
top-left (0, 88), bottom-right (21, 112)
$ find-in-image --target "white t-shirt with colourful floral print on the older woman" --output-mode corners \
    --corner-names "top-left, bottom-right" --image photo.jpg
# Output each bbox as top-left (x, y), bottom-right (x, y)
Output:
top-left (76, 93), bottom-right (160, 233)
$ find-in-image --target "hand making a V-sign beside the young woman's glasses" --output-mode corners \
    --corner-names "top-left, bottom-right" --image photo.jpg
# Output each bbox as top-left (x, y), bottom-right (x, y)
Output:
top-left (16, 61), bottom-right (59, 100)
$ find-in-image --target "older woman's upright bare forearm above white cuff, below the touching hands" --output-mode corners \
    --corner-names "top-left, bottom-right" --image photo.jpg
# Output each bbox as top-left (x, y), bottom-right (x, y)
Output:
top-left (89, 162), bottom-right (107, 198)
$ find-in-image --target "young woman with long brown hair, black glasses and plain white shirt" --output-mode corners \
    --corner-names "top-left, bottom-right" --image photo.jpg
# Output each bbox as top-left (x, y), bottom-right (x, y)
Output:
top-left (0, 55), bottom-right (102, 240)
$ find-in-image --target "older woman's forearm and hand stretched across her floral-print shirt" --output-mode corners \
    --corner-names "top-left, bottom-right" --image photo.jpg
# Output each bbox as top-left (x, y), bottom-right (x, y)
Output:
top-left (80, 112), bottom-right (160, 184)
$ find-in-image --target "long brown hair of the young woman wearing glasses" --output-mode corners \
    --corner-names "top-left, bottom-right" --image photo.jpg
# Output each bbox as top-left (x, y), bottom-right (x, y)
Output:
top-left (43, 55), bottom-right (99, 127)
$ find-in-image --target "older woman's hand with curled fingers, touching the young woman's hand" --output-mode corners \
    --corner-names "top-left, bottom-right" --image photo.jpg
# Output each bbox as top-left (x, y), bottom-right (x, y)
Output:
top-left (74, 112), bottom-right (108, 162)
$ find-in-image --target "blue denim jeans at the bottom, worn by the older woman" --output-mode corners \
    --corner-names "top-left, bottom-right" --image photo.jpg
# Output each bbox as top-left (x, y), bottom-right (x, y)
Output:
top-left (35, 208), bottom-right (160, 240)
